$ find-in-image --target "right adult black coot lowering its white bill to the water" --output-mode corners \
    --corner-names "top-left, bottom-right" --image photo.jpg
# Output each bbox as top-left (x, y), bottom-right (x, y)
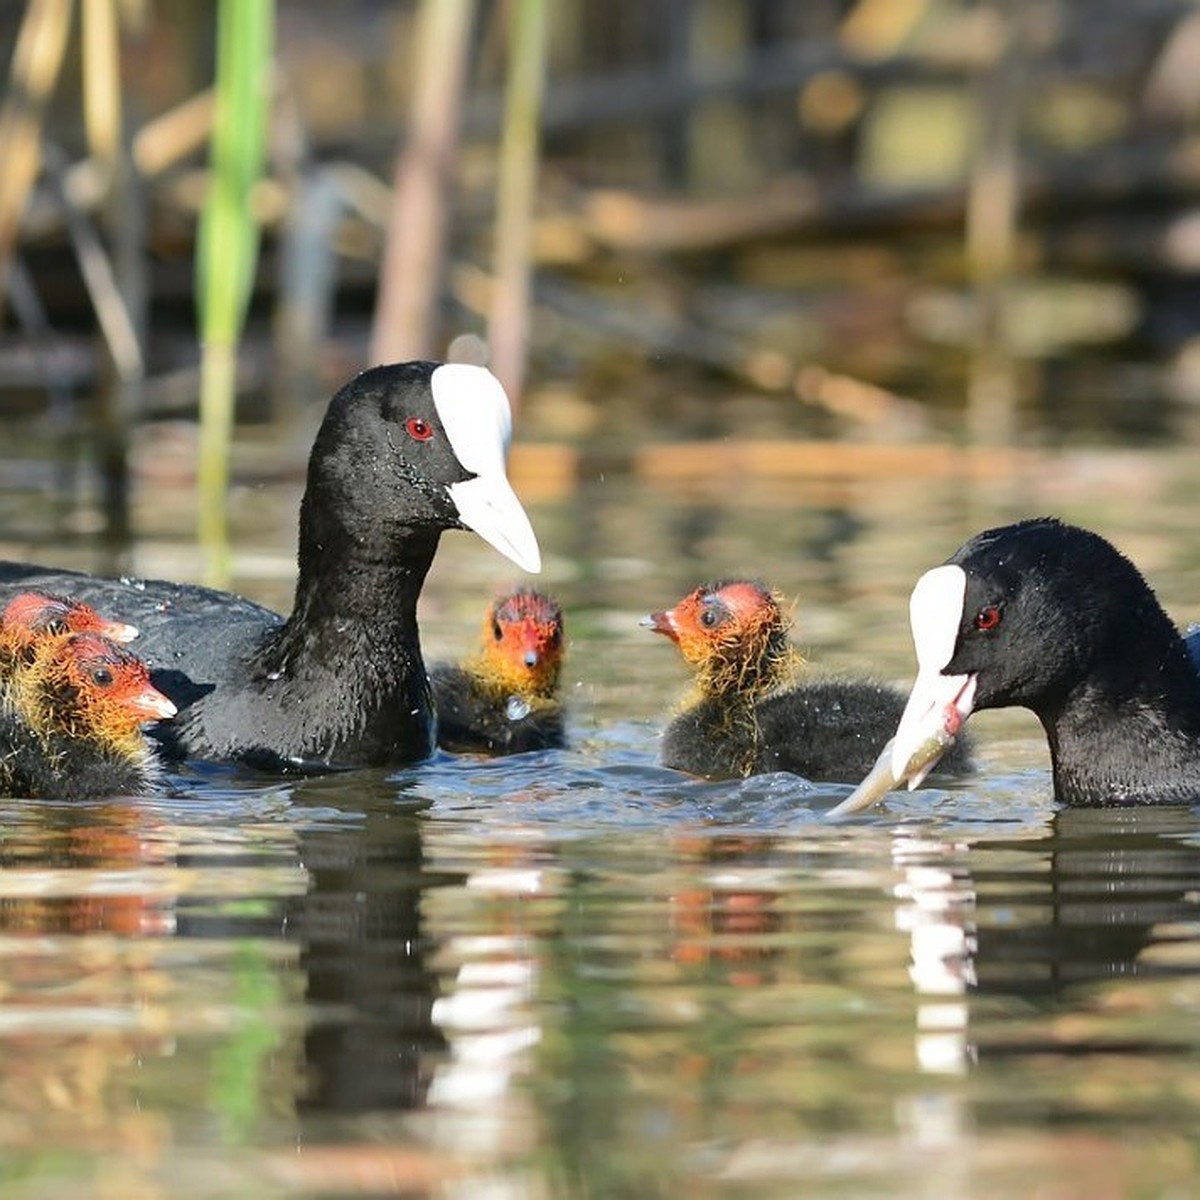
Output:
top-left (859, 517), bottom-right (1200, 805)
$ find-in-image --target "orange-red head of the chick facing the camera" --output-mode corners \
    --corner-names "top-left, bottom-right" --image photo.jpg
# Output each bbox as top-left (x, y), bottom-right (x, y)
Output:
top-left (480, 588), bottom-right (563, 700)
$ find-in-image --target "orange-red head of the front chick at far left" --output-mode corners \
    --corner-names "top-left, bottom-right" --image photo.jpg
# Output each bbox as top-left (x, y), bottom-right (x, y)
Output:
top-left (22, 634), bottom-right (175, 739)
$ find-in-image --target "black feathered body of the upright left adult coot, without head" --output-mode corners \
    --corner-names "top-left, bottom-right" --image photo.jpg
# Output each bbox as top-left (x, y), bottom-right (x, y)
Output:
top-left (0, 535), bottom-right (438, 770)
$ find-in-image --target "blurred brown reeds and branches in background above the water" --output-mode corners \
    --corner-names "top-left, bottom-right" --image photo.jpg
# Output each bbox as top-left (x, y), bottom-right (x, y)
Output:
top-left (0, 0), bottom-right (1200, 578)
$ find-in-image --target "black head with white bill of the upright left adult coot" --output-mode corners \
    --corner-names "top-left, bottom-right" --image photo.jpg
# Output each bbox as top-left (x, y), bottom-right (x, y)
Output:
top-left (301, 362), bottom-right (541, 571)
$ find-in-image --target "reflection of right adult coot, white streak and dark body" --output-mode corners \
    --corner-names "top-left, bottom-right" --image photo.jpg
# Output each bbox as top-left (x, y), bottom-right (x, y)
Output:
top-left (892, 808), bottom-right (1200, 1121)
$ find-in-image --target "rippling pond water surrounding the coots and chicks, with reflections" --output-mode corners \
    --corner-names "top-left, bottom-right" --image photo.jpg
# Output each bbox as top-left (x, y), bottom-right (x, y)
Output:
top-left (0, 454), bottom-right (1200, 1200)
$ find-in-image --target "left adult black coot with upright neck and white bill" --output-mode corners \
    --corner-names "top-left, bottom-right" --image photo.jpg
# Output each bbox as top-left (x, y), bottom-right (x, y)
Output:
top-left (0, 362), bottom-right (540, 770)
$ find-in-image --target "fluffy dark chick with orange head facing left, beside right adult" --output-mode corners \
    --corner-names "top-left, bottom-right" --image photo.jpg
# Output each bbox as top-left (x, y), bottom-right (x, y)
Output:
top-left (643, 580), bottom-right (970, 781)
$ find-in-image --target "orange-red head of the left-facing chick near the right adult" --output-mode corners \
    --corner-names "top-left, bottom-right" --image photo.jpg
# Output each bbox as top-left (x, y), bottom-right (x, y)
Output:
top-left (642, 580), bottom-right (796, 696)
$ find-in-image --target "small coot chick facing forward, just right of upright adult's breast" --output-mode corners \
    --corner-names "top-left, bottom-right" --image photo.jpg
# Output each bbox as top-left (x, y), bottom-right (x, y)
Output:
top-left (430, 588), bottom-right (566, 755)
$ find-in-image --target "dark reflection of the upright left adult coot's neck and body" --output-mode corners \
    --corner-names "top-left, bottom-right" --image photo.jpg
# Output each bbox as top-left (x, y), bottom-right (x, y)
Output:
top-left (169, 772), bottom-right (445, 1113)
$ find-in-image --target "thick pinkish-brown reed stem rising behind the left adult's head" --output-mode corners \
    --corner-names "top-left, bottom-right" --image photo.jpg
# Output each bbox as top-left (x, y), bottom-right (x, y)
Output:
top-left (370, 0), bottom-right (475, 364)
